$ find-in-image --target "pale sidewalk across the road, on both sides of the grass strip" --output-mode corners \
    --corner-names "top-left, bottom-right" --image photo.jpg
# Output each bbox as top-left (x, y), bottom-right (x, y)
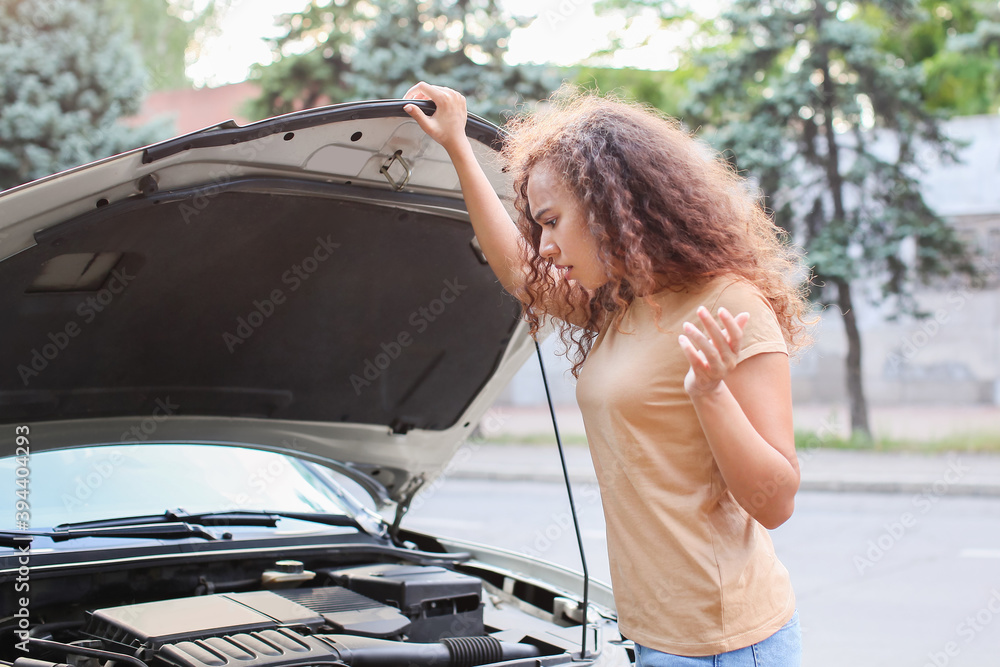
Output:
top-left (460, 406), bottom-right (1000, 497)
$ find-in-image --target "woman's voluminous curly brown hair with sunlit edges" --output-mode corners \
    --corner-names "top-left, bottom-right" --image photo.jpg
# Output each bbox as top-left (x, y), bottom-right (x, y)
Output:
top-left (501, 87), bottom-right (808, 376)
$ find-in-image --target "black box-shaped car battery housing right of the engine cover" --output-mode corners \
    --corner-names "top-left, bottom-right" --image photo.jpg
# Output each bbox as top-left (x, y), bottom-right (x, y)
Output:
top-left (318, 563), bottom-right (484, 642)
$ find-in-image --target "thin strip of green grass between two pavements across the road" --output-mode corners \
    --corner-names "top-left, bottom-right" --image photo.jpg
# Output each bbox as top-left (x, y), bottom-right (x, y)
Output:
top-left (485, 431), bottom-right (1000, 454)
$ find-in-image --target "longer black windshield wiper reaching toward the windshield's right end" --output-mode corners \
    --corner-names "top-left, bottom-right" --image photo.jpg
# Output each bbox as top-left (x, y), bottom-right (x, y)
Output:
top-left (54, 509), bottom-right (363, 532)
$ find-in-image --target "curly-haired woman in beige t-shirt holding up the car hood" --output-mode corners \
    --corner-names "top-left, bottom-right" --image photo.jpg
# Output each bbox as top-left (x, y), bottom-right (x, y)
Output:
top-left (404, 82), bottom-right (805, 667)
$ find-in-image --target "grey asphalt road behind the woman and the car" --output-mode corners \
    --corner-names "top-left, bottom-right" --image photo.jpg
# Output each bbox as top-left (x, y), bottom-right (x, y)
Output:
top-left (404, 479), bottom-right (1000, 667)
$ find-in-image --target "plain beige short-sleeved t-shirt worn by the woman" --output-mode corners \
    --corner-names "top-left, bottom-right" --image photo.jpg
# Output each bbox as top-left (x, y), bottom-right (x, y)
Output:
top-left (576, 278), bottom-right (795, 656)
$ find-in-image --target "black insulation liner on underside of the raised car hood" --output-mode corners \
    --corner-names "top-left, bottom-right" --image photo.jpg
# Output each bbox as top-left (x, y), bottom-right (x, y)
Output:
top-left (0, 179), bottom-right (520, 432)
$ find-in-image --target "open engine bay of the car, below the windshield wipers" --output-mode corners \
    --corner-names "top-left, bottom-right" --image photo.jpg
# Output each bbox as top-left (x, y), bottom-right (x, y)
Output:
top-left (0, 548), bottom-right (600, 667)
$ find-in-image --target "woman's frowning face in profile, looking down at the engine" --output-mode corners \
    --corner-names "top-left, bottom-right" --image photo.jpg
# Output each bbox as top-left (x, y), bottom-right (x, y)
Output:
top-left (528, 164), bottom-right (608, 289)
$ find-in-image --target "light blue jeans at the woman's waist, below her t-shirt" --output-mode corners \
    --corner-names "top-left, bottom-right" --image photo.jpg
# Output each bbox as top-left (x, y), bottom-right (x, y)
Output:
top-left (635, 610), bottom-right (802, 667)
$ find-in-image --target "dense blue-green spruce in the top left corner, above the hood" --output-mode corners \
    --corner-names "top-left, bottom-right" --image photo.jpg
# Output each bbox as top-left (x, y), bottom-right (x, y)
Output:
top-left (0, 0), bottom-right (168, 188)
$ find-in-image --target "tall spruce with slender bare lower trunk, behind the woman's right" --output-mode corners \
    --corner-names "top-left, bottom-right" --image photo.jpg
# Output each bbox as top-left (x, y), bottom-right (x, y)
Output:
top-left (604, 0), bottom-right (977, 438)
